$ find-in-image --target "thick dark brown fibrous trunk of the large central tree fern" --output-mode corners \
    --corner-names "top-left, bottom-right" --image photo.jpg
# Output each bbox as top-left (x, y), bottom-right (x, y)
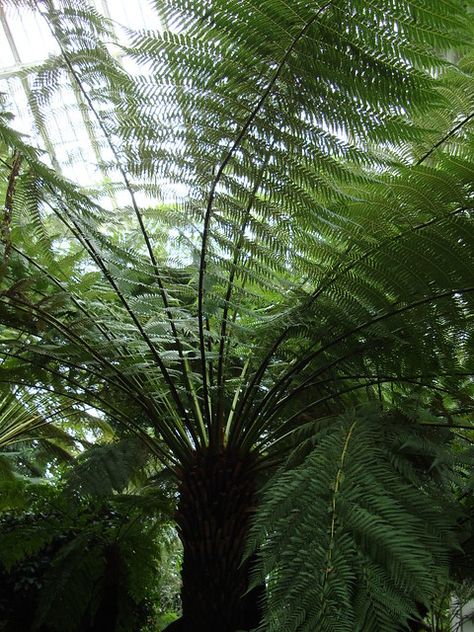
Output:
top-left (168, 451), bottom-right (263, 632)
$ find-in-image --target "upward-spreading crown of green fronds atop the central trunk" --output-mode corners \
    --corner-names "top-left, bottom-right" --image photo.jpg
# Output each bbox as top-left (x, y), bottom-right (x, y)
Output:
top-left (0, 0), bottom-right (474, 461)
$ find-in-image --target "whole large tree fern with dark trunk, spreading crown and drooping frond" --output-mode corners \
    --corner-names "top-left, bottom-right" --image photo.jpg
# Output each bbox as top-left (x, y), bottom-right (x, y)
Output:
top-left (0, 0), bottom-right (474, 632)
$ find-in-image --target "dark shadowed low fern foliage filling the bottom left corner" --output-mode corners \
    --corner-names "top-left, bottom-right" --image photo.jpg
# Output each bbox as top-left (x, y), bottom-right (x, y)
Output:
top-left (0, 478), bottom-right (175, 632)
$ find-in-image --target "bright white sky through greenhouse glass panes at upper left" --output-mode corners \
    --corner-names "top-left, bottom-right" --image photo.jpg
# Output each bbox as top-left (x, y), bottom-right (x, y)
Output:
top-left (0, 0), bottom-right (160, 193)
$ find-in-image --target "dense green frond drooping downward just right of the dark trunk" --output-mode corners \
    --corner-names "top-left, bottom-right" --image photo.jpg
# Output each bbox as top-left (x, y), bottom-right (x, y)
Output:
top-left (250, 408), bottom-right (466, 632)
